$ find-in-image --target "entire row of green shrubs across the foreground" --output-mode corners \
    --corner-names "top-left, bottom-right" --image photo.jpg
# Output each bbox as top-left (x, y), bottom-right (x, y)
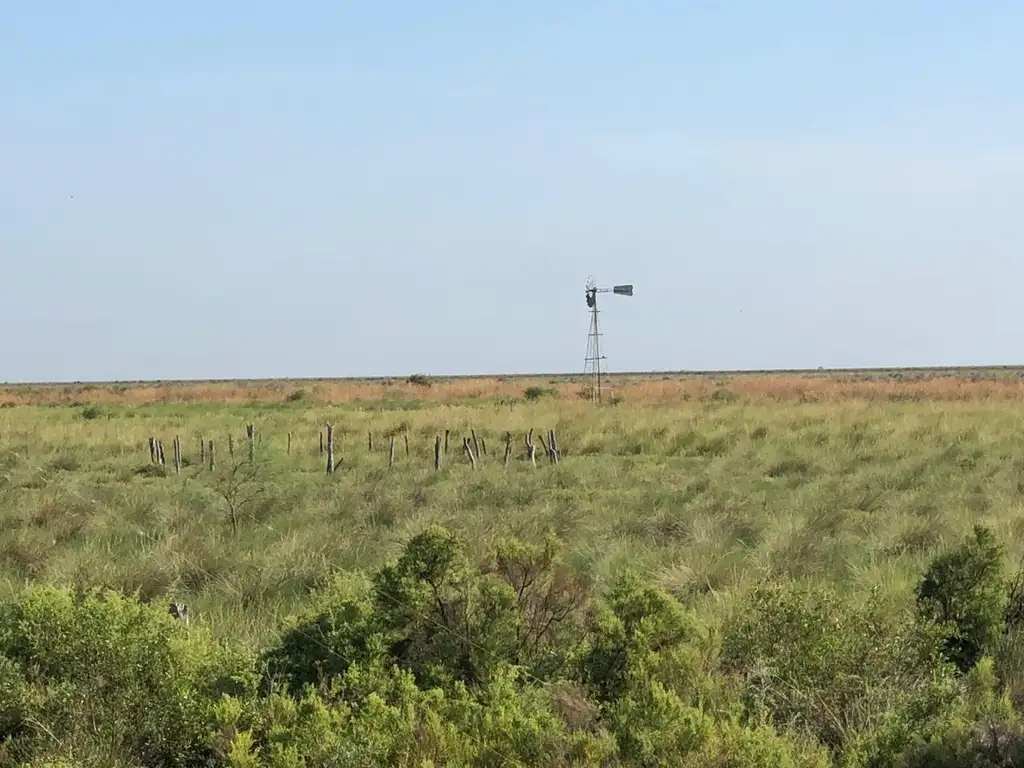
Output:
top-left (6, 527), bottom-right (1024, 768)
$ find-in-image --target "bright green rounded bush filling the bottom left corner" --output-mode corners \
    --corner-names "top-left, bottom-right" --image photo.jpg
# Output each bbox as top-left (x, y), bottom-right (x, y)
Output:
top-left (0, 587), bottom-right (255, 766)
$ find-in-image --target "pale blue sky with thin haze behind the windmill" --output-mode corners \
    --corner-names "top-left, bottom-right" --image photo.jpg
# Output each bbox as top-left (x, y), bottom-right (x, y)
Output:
top-left (0, 0), bottom-right (1024, 381)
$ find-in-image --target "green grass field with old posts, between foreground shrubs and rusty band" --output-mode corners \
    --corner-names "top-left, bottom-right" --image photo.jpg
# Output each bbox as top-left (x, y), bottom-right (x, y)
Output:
top-left (0, 397), bottom-right (1024, 647)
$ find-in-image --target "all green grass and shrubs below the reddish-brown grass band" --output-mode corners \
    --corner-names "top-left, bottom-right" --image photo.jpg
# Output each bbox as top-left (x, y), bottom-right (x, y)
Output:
top-left (0, 382), bottom-right (1024, 768)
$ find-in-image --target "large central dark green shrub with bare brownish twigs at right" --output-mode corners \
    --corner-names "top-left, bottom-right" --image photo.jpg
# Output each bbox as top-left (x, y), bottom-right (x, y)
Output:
top-left (266, 525), bottom-right (586, 689)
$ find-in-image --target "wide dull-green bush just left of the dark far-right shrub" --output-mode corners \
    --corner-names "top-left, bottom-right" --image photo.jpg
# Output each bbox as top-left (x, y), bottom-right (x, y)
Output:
top-left (722, 586), bottom-right (957, 755)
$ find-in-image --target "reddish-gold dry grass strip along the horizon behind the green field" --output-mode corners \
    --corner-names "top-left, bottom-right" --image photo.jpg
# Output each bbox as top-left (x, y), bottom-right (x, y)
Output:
top-left (6, 371), bottom-right (1024, 406)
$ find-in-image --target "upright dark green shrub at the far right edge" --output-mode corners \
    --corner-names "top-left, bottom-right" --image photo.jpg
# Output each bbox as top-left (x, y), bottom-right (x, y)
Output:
top-left (918, 525), bottom-right (1009, 672)
